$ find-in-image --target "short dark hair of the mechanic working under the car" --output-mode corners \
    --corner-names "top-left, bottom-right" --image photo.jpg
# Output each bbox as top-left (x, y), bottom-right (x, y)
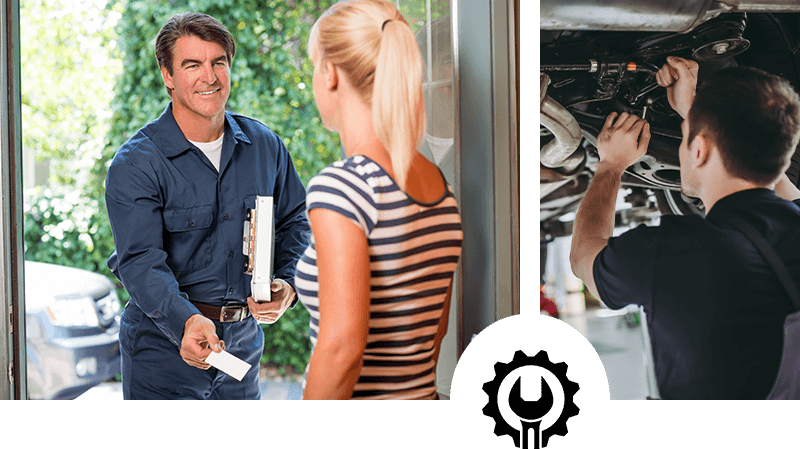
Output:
top-left (688, 67), bottom-right (800, 185)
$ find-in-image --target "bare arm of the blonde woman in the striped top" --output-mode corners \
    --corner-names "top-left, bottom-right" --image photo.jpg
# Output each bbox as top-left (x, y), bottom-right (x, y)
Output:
top-left (303, 208), bottom-right (370, 399)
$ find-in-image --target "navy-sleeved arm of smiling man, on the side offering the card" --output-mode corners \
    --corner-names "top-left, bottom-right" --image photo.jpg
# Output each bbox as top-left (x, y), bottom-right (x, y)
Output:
top-left (105, 162), bottom-right (199, 347)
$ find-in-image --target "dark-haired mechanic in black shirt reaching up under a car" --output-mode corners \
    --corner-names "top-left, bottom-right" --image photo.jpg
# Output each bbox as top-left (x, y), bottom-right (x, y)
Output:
top-left (570, 57), bottom-right (800, 399)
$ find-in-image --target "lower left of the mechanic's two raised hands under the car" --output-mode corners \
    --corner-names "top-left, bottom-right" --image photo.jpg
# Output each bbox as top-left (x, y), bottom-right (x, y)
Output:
top-left (597, 112), bottom-right (650, 171)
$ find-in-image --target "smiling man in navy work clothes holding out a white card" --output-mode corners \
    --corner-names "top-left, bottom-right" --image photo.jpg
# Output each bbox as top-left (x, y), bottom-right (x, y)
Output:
top-left (106, 13), bottom-right (310, 399)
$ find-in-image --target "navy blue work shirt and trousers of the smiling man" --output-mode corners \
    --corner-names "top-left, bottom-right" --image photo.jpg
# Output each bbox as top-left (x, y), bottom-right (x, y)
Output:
top-left (106, 103), bottom-right (310, 399)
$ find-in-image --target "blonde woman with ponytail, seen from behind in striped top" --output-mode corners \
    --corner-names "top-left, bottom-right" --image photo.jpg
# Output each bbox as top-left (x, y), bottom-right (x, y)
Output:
top-left (295, 0), bottom-right (462, 399)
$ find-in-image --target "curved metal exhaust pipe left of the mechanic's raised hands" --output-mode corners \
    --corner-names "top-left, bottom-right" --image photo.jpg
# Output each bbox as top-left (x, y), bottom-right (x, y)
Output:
top-left (539, 72), bottom-right (586, 172)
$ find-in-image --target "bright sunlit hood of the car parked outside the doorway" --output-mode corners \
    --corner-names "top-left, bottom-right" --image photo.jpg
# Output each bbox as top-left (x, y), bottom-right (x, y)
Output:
top-left (25, 260), bottom-right (114, 312)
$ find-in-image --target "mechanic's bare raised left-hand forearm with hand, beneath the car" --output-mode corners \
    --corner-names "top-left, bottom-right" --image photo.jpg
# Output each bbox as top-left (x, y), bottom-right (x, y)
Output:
top-left (569, 112), bottom-right (650, 299)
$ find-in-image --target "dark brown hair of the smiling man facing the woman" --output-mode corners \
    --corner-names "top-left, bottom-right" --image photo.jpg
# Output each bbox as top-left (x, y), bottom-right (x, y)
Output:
top-left (156, 12), bottom-right (236, 95)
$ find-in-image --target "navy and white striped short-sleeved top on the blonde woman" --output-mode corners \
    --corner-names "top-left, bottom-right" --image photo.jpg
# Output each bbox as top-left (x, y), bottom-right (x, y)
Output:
top-left (295, 155), bottom-right (463, 399)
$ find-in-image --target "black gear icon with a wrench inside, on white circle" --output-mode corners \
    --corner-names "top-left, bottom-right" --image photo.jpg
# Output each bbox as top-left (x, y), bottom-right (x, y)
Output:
top-left (482, 350), bottom-right (580, 449)
